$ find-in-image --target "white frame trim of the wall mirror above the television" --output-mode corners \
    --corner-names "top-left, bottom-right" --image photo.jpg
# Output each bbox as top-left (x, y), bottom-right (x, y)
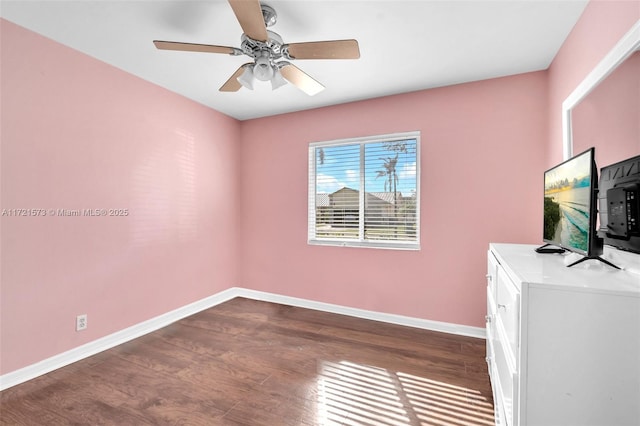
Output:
top-left (562, 19), bottom-right (640, 160)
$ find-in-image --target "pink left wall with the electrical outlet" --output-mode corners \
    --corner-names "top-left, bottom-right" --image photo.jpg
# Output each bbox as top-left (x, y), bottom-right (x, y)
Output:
top-left (0, 20), bottom-right (240, 373)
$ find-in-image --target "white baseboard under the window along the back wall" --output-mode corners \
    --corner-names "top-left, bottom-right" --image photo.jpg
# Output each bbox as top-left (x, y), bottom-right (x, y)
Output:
top-left (237, 288), bottom-right (486, 339)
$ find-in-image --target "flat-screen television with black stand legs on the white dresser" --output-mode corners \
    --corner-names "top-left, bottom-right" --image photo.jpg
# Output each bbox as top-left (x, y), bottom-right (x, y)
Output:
top-left (536, 148), bottom-right (617, 268)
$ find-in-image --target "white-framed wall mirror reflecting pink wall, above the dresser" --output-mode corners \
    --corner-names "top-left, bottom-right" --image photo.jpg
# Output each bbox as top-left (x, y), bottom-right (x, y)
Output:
top-left (562, 20), bottom-right (640, 167)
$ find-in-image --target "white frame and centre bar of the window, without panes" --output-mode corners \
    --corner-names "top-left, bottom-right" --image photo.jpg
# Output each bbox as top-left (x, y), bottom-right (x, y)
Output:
top-left (307, 131), bottom-right (421, 250)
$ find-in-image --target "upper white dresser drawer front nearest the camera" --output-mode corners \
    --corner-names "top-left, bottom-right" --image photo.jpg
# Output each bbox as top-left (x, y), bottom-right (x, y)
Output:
top-left (496, 267), bottom-right (520, 366)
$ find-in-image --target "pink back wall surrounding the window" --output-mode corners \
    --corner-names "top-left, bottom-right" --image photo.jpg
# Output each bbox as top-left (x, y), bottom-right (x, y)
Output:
top-left (240, 72), bottom-right (547, 326)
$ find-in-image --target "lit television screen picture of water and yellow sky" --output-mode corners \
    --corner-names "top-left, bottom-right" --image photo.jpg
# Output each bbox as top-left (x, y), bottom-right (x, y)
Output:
top-left (544, 150), bottom-right (593, 253)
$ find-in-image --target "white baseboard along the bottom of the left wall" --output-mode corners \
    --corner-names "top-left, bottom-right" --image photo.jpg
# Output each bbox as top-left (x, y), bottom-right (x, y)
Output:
top-left (0, 288), bottom-right (237, 391)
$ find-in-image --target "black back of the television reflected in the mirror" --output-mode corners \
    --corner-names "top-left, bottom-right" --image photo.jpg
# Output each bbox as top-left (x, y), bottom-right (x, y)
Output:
top-left (598, 155), bottom-right (640, 253)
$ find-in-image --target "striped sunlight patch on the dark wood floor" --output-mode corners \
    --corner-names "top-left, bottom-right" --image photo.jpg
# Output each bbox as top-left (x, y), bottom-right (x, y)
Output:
top-left (317, 361), bottom-right (494, 426)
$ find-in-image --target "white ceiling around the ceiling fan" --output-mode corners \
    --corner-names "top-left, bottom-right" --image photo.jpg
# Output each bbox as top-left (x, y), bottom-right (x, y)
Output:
top-left (0, 0), bottom-right (588, 120)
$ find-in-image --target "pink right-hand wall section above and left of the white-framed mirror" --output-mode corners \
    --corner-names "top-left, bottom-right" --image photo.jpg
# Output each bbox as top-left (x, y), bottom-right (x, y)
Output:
top-left (547, 0), bottom-right (640, 166)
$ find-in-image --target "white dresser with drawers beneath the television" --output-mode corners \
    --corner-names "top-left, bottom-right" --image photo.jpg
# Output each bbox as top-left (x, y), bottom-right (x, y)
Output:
top-left (487, 244), bottom-right (640, 426)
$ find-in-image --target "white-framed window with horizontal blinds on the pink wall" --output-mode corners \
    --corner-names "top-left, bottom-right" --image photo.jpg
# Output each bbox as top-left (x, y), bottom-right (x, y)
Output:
top-left (308, 132), bottom-right (420, 250)
